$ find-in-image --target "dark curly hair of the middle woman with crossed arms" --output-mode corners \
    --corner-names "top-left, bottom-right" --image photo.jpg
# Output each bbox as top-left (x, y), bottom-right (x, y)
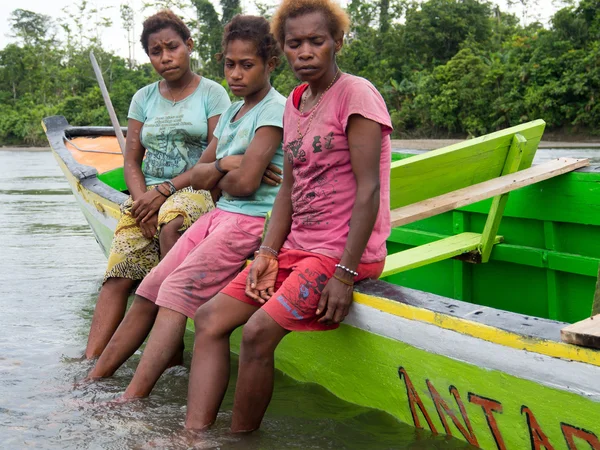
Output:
top-left (216, 14), bottom-right (281, 63)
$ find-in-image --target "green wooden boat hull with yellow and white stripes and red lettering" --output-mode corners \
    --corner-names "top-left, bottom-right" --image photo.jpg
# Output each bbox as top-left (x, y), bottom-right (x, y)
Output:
top-left (46, 118), bottom-right (600, 450)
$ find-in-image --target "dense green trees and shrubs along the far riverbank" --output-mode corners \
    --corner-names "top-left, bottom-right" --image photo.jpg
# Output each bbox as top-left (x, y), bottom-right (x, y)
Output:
top-left (0, 0), bottom-right (600, 144)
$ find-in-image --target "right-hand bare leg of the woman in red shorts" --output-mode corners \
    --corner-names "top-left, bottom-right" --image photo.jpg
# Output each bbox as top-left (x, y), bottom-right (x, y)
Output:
top-left (231, 311), bottom-right (289, 433)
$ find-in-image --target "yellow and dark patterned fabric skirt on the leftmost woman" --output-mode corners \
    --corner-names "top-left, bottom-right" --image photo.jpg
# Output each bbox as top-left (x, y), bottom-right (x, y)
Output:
top-left (104, 186), bottom-right (214, 283)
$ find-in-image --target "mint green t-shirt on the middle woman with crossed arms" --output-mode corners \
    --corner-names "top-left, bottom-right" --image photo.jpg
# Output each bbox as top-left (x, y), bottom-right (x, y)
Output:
top-left (214, 88), bottom-right (285, 217)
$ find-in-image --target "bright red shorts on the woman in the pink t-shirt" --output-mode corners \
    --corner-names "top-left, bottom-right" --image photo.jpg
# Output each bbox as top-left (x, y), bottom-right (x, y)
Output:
top-left (221, 248), bottom-right (385, 331)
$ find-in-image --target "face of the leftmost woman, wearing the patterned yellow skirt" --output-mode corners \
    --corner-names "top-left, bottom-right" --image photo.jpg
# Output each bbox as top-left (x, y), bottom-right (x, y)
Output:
top-left (148, 28), bottom-right (193, 81)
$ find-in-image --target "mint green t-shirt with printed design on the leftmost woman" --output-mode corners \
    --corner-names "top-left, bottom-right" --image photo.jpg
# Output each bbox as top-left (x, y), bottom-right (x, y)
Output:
top-left (127, 77), bottom-right (231, 186)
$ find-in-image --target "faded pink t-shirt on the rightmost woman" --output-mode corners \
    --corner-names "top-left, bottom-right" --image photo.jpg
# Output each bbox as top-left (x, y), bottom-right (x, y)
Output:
top-left (283, 74), bottom-right (392, 263)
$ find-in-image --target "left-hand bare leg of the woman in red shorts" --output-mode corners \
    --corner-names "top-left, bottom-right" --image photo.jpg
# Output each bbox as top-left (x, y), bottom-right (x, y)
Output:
top-left (185, 294), bottom-right (258, 430)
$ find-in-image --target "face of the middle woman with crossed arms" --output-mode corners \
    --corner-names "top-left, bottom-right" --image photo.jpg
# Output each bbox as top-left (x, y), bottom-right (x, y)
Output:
top-left (224, 39), bottom-right (275, 97)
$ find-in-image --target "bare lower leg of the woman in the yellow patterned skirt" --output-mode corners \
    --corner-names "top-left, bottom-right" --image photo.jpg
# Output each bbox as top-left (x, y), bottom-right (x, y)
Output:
top-left (85, 278), bottom-right (135, 359)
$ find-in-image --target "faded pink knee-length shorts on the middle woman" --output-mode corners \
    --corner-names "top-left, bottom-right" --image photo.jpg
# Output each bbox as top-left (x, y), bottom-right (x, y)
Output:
top-left (136, 208), bottom-right (265, 318)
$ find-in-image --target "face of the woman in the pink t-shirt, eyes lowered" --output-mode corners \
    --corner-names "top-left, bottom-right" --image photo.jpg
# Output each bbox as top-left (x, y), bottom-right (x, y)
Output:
top-left (283, 12), bottom-right (342, 82)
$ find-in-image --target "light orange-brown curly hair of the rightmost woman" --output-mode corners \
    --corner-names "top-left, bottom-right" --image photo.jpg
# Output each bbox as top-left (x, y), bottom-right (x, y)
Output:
top-left (271, 0), bottom-right (350, 47)
